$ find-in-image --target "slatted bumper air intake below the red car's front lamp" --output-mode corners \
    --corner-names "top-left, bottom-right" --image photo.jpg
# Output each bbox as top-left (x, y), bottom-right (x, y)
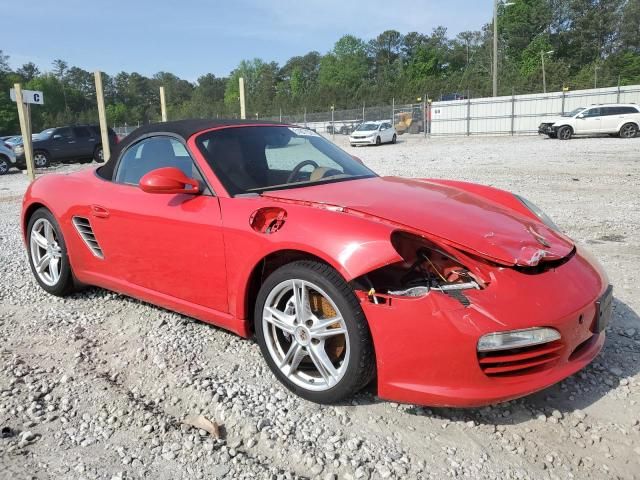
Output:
top-left (478, 340), bottom-right (564, 377)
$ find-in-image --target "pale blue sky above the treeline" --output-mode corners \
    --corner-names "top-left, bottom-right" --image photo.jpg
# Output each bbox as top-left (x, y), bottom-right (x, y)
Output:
top-left (0, 0), bottom-right (493, 81)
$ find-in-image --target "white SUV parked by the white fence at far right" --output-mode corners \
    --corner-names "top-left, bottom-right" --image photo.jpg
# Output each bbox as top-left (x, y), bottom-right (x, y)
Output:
top-left (538, 103), bottom-right (640, 140)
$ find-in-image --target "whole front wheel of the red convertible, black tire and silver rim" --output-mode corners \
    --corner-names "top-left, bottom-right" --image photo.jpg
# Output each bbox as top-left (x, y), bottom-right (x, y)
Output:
top-left (254, 260), bottom-right (375, 404)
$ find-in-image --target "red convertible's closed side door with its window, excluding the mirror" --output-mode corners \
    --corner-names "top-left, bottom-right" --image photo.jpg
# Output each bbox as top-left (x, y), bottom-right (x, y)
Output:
top-left (90, 136), bottom-right (228, 312)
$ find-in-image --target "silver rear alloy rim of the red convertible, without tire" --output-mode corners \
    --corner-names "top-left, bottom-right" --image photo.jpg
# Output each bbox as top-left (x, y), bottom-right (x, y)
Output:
top-left (30, 218), bottom-right (62, 287)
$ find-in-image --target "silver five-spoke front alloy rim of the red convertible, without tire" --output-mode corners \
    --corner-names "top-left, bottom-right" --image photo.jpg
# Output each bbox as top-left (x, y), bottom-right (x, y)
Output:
top-left (262, 279), bottom-right (350, 391)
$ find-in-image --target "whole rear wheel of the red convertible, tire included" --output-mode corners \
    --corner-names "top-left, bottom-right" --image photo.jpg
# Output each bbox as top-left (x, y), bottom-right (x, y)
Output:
top-left (27, 208), bottom-right (74, 297)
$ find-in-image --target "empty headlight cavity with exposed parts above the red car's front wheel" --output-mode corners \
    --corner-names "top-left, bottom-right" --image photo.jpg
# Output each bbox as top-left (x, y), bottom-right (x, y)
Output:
top-left (358, 231), bottom-right (484, 306)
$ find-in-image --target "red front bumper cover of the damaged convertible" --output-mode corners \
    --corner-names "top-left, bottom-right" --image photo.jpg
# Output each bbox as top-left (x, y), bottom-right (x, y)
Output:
top-left (358, 246), bottom-right (608, 407)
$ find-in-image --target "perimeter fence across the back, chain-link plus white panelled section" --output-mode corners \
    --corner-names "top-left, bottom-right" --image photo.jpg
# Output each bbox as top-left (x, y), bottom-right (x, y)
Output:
top-left (114, 85), bottom-right (640, 137)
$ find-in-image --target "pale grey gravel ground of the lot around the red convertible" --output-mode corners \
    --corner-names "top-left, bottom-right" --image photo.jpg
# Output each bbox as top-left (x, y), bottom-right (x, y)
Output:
top-left (0, 137), bottom-right (640, 479)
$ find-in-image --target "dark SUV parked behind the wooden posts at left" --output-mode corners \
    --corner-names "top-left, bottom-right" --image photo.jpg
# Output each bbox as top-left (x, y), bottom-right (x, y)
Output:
top-left (13, 125), bottom-right (118, 168)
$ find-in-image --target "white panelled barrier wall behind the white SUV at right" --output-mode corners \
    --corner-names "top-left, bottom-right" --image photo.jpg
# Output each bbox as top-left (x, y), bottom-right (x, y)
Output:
top-left (430, 85), bottom-right (640, 135)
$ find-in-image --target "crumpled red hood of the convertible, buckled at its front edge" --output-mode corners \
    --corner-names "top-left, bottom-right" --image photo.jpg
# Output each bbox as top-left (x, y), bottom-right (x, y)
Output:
top-left (263, 177), bottom-right (574, 266)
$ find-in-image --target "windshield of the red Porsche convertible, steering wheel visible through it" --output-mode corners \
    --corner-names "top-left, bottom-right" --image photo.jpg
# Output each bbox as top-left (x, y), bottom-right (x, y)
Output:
top-left (196, 126), bottom-right (376, 195)
